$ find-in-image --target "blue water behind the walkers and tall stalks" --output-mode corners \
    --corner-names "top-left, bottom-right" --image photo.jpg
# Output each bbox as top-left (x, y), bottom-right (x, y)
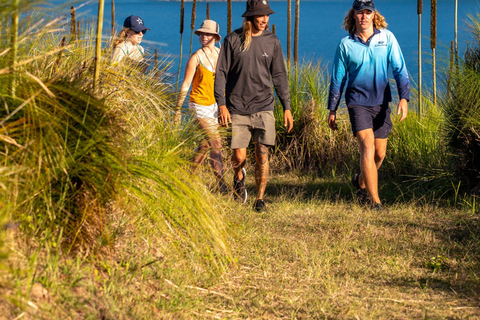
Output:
top-left (72, 0), bottom-right (480, 85)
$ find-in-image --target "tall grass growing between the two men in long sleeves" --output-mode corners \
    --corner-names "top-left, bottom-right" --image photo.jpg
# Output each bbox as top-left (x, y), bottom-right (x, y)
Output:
top-left (274, 61), bottom-right (357, 174)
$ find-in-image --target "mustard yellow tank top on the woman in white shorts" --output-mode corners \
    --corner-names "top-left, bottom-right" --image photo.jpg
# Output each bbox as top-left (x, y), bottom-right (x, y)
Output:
top-left (189, 59), bottom-right (216, 106)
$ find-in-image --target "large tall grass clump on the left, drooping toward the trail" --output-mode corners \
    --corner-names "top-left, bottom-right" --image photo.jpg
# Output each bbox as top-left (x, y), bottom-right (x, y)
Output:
top-left (0, 0), bottom-right (232, 292)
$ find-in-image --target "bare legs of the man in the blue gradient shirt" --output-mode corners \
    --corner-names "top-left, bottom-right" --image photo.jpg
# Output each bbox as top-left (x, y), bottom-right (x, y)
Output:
top-left (356, 129), bottom-right (386, 203)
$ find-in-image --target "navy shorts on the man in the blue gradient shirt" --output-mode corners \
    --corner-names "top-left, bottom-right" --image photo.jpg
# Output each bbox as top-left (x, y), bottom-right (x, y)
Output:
top-left (348, 103), bottom-right (393, 139)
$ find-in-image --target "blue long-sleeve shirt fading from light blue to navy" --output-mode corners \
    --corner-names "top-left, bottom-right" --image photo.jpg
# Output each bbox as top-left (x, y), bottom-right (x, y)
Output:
top-left (328, 29), bottom-right (410, 111)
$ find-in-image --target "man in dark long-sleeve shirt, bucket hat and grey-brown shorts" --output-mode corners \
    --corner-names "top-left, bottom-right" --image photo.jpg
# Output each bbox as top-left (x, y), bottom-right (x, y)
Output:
top-left (215, 0), bottom-right (293, 211)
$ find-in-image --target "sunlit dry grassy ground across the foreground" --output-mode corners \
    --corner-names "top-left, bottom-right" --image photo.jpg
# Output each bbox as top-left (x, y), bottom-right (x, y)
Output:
top-left (0, 173), bottom-right (480, 319)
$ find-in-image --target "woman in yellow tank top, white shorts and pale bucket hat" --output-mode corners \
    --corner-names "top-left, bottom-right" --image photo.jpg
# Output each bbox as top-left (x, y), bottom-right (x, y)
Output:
top-left (176, 20), bottom-right (228, 193)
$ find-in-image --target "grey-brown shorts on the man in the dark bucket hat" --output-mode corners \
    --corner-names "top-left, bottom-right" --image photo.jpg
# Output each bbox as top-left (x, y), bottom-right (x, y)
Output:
top-left (230, 111), bottom-right (275, 149)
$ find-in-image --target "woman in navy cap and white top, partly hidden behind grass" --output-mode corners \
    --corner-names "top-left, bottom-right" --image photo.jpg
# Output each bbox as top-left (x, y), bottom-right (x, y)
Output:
top-left (112, 15), bottom-right (150, 63)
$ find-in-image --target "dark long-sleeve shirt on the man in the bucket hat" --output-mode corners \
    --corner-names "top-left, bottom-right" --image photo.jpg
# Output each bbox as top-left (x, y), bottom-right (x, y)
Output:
top-left (215, 29), bottom-right (290, 114)
